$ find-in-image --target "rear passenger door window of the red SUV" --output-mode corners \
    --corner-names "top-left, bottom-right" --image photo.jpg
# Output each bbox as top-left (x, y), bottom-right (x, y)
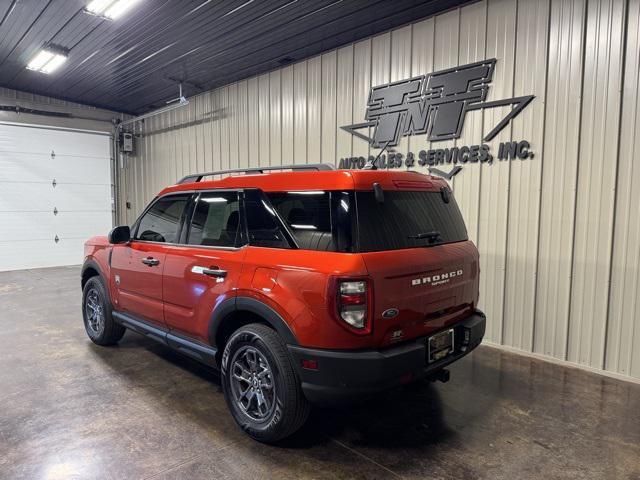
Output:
top-left (187, 192), bottom-right (241, 247)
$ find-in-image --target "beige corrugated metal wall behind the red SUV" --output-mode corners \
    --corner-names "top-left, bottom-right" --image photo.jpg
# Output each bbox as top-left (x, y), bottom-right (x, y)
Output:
top-left (120, 0), bottom-right (640, 378)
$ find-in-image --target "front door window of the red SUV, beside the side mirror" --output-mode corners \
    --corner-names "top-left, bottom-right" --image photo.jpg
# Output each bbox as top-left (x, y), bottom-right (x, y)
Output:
top-left (136, 195), bottom-right (190, 243)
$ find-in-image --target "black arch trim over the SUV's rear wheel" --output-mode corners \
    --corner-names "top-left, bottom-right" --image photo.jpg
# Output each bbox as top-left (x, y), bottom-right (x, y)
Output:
top-left (209, 296), bottom-right (298, 349)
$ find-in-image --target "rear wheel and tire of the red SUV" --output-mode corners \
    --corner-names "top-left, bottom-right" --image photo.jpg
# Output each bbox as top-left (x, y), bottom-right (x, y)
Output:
top-left (221, 323), bottom-right (310, 443)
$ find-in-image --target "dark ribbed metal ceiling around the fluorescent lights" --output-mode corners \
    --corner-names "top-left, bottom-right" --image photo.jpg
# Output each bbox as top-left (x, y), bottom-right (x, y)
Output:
top-left (0, 0), bottom-right (468, 114)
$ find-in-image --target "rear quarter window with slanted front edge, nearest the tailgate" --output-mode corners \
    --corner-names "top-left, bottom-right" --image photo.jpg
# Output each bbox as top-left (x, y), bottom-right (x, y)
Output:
top-left (267, 190), bottom-right (335, 252)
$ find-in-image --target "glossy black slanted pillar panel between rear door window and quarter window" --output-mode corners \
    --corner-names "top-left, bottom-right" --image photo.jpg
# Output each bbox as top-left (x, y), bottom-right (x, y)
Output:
top-left (244, 190), bottom-right (292, 248)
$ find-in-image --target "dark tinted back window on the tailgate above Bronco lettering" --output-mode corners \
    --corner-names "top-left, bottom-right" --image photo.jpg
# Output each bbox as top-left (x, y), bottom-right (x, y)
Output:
top-left (356, 191), bottom-right (467, 252)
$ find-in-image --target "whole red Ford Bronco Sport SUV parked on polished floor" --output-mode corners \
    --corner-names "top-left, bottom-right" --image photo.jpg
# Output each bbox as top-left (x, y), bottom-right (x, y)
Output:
top-left (82, 165), bottom-right (485, 442)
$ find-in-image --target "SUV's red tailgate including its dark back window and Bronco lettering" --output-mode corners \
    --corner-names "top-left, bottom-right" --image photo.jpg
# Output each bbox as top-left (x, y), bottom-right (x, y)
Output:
top-left (356, 188), bottom-right (479, 346)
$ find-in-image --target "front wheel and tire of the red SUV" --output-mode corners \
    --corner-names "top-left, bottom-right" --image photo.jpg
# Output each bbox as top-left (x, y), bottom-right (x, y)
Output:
top-left (82, 276), bottom-right (125, 346)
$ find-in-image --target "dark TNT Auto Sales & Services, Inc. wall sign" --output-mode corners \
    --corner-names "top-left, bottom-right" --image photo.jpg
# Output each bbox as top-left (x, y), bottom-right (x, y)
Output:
top-left (339, 58), bottom-right (534, 180)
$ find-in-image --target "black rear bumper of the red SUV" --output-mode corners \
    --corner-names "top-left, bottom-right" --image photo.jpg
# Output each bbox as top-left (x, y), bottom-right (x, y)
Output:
top-left (288, 310), bottom-right (486, 404)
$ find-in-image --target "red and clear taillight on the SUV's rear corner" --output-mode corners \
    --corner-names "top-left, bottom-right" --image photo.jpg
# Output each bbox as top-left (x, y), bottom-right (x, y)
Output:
top-left (336, 279), bottom-right (372, 334)
